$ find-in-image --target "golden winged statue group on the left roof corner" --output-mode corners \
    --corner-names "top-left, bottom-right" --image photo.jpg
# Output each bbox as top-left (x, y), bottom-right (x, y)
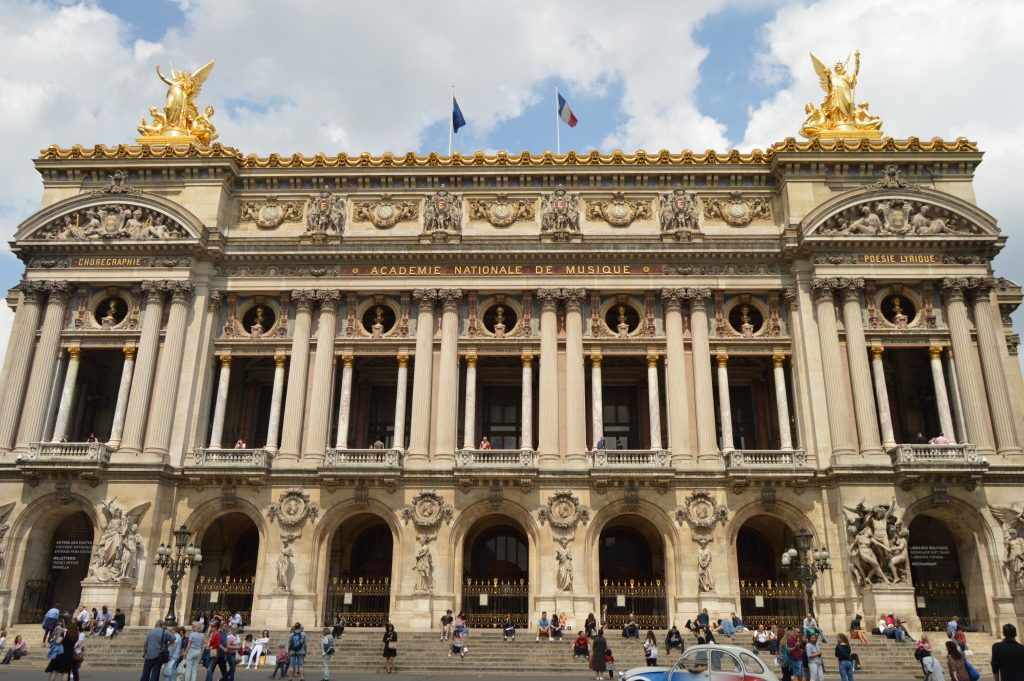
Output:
top-left (138, 59), bottom-right (217, 144)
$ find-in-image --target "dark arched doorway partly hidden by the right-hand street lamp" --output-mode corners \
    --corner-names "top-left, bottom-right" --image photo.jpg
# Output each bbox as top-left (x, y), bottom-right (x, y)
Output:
top-left (736, 514), bottom-right (807, 627)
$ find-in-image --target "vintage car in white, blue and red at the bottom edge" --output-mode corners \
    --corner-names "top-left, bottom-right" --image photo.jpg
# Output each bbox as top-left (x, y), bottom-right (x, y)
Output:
top-left (618, 645), bottom-right (778, 681)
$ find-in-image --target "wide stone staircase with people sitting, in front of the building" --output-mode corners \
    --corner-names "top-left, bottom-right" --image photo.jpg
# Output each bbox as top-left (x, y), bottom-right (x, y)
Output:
top-left (7, 625), bottom-right (997, 679)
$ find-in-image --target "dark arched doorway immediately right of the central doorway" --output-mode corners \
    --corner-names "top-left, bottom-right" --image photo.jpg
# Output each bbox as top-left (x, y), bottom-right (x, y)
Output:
top-left (598, 515), bottom-right (668, 629)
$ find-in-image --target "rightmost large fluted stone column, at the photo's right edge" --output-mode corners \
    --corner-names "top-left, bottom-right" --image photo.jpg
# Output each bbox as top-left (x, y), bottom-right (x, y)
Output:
top-left (971, 279), bottom-right (1021, 455)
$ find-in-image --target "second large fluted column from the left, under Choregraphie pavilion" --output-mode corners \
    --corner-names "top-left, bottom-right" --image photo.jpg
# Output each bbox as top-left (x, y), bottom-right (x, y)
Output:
top-left (16, 282), bottom-right (71, 451)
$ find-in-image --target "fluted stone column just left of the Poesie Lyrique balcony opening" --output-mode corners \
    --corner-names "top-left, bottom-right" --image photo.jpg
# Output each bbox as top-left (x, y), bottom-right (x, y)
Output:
top-left (843, 279), bottom-right (882, 456)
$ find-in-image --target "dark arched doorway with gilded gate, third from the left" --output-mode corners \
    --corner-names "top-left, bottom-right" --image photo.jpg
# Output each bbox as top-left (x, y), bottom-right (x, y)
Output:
top-left (324, 513), bottom-right (394, 627)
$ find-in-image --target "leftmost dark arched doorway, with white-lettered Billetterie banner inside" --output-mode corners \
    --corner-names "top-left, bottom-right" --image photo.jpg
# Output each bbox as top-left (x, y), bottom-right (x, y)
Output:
top-left (18, 511), bottom-right (95, 624)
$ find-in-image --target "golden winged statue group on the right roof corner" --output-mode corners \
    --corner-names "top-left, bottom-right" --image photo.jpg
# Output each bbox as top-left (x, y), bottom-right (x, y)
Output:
top-left (800, 50), bottom-right (882, 139)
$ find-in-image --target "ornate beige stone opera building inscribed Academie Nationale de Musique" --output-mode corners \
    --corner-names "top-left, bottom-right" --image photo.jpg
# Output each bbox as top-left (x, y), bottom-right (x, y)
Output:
top-left (0, 138), bottom-right (1024, 630)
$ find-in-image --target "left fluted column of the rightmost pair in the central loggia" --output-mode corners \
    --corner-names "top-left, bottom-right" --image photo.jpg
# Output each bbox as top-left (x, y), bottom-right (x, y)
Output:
top-left (662, 289), bottom-right (691, 464)
